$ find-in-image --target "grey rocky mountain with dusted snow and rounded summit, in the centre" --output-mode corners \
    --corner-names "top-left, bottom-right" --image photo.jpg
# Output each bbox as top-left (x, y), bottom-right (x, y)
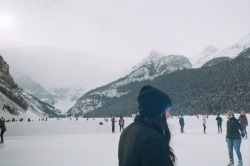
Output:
top-left (67, 51), bottom-right (192, 116)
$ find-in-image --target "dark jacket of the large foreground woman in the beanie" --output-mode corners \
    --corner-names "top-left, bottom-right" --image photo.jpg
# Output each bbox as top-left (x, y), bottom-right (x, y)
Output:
top-left (118, 115), bottom-right (172, 166)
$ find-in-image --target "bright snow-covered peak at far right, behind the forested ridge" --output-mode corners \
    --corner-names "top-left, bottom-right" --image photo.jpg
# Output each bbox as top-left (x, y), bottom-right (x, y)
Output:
top-left (190, 33), bottom-right (250, 68)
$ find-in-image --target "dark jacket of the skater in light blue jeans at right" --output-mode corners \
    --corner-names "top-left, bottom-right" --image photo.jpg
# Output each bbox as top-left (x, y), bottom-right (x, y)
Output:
top-left (226, 117), bottom-right (243, 139)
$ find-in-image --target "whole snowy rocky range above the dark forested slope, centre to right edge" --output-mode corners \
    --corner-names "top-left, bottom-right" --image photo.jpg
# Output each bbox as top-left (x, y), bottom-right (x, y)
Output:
top-left (67, 34), bottom-right (250, 116)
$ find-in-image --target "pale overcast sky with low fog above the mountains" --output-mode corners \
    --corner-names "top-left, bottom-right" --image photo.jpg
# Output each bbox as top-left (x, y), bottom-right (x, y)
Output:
top-left (0, 0), bottom-right (250, 88)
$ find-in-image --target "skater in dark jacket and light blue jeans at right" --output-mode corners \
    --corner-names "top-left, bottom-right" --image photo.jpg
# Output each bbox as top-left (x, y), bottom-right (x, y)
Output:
top-left (226, 111), bottom-right (245, 166)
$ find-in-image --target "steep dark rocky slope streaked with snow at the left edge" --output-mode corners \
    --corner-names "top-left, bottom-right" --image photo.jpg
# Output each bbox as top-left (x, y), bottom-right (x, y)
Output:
top-left (0, 55), bottom-right (61, 118)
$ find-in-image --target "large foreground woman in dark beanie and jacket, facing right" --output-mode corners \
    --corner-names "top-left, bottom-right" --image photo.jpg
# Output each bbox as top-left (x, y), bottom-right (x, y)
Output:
top-left (118, 85), bottom-right (176, 166)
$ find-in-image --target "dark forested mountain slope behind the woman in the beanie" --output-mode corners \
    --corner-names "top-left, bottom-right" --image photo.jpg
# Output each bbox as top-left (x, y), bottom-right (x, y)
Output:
top-left (84, 48), bottom-right (250, 117)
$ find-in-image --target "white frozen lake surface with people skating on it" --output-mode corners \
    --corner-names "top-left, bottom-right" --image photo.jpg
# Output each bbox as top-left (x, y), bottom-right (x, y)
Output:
top-left (0, 115), bottom-right (250, 166)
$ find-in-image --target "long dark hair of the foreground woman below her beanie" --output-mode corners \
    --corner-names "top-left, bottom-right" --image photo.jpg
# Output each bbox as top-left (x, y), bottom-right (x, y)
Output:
top-left (144, 114), bottom-right (176, 166)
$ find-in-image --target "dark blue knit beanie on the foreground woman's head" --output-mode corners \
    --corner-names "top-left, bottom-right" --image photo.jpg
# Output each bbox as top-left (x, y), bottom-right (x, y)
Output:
top-left (137, 85), bottom-right (172, 117)
